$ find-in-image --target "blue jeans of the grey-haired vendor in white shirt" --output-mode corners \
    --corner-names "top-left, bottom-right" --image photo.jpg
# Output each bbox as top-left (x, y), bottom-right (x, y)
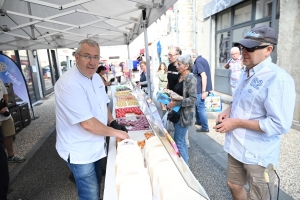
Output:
top-left (67, 159), bottom-right (102, 200)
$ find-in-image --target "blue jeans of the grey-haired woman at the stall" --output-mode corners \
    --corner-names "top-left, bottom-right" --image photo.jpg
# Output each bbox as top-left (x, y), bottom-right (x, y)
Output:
top-left (174, 120), bottom-right (189, 165)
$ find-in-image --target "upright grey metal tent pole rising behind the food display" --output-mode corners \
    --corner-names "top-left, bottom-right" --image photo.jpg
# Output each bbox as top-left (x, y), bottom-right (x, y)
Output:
top-left (142, 9), bottom-right (152, 99)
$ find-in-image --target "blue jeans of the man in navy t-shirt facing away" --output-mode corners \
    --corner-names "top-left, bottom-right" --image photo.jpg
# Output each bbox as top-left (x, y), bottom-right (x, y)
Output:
top-left (196, 94), bottom-right (209, 130)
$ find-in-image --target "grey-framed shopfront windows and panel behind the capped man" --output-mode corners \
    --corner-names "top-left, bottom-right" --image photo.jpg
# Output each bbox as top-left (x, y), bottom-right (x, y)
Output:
top-left (204, 0), bottom-right (280, 95)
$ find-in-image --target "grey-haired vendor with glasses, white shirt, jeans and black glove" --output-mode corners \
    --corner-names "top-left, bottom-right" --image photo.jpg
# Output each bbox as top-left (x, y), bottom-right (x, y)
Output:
top-left (54, 39), bottom-right (129, 200)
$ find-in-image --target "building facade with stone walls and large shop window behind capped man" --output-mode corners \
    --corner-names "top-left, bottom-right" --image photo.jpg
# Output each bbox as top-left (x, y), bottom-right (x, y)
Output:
top-left (196, 0), bottom-right (300, 124)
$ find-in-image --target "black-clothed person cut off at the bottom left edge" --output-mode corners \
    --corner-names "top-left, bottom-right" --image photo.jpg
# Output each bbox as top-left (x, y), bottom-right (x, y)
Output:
top-left (0, 127), bottom-right (9, 200)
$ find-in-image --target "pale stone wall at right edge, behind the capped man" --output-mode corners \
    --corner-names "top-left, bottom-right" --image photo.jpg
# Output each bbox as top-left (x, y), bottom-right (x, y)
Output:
top-left (277, 0), bottom-right (300, 123)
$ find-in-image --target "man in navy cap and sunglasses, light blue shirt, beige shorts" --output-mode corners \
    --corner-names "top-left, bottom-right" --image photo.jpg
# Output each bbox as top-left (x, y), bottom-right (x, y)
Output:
top-left (214, 26), bottom-right (296, 200)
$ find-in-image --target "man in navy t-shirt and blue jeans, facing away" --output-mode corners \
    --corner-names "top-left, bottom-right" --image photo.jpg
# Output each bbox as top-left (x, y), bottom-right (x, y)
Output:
top-left (193, 52), bottom-right (212, 132)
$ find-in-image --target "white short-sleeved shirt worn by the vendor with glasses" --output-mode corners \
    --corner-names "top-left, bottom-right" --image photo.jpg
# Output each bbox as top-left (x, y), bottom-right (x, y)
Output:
top-left (54, 67), bottom-right (109, 164)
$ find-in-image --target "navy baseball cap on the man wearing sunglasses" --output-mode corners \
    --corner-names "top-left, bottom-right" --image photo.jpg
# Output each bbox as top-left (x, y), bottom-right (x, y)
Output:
top-left (234, 25), bottom-right (278, 48)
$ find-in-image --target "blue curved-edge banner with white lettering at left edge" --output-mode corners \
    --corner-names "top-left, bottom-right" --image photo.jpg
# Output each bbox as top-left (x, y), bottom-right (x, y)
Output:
top-left (0, 54), bottom-right (31, 108)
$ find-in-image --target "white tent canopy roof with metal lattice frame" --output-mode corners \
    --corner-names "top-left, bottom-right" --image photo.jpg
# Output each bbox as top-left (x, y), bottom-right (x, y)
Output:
top-left (0, 0), bottom-right (177, 50)
